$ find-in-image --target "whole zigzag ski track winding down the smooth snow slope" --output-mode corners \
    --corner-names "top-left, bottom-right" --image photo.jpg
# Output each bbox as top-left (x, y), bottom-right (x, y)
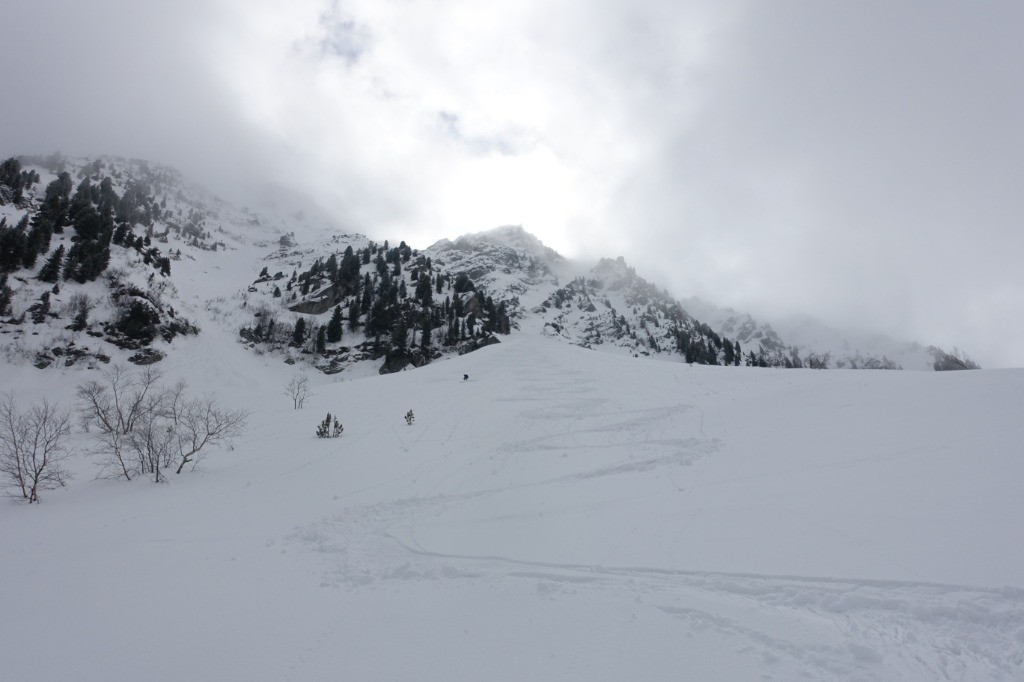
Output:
top-left (289, 350), bottom-right (1024, 680)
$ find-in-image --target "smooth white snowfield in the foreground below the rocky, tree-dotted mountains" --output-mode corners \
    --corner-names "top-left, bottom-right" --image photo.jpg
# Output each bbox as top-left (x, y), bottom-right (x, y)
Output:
top-left (0, 242), bottom-right (1024, 681)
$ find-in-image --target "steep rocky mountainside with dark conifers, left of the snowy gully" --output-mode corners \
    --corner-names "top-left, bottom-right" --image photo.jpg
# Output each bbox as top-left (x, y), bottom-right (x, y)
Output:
top-left (0, 155), bottom-right (323, 369)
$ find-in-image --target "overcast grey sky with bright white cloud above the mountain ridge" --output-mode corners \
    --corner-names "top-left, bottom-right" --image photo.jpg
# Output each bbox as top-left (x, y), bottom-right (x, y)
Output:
top-left (0, 0), bottom-right (1024, 367)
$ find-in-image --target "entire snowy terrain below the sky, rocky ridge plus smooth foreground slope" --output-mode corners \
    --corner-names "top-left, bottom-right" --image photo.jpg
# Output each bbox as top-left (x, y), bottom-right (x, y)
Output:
top-left (0, 151), bottom-right (1024, 682)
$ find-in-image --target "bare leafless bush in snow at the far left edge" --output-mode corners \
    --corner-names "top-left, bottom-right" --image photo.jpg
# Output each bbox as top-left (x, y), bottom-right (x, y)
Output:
top-left (0, 394), bottom-right (73, 504)
